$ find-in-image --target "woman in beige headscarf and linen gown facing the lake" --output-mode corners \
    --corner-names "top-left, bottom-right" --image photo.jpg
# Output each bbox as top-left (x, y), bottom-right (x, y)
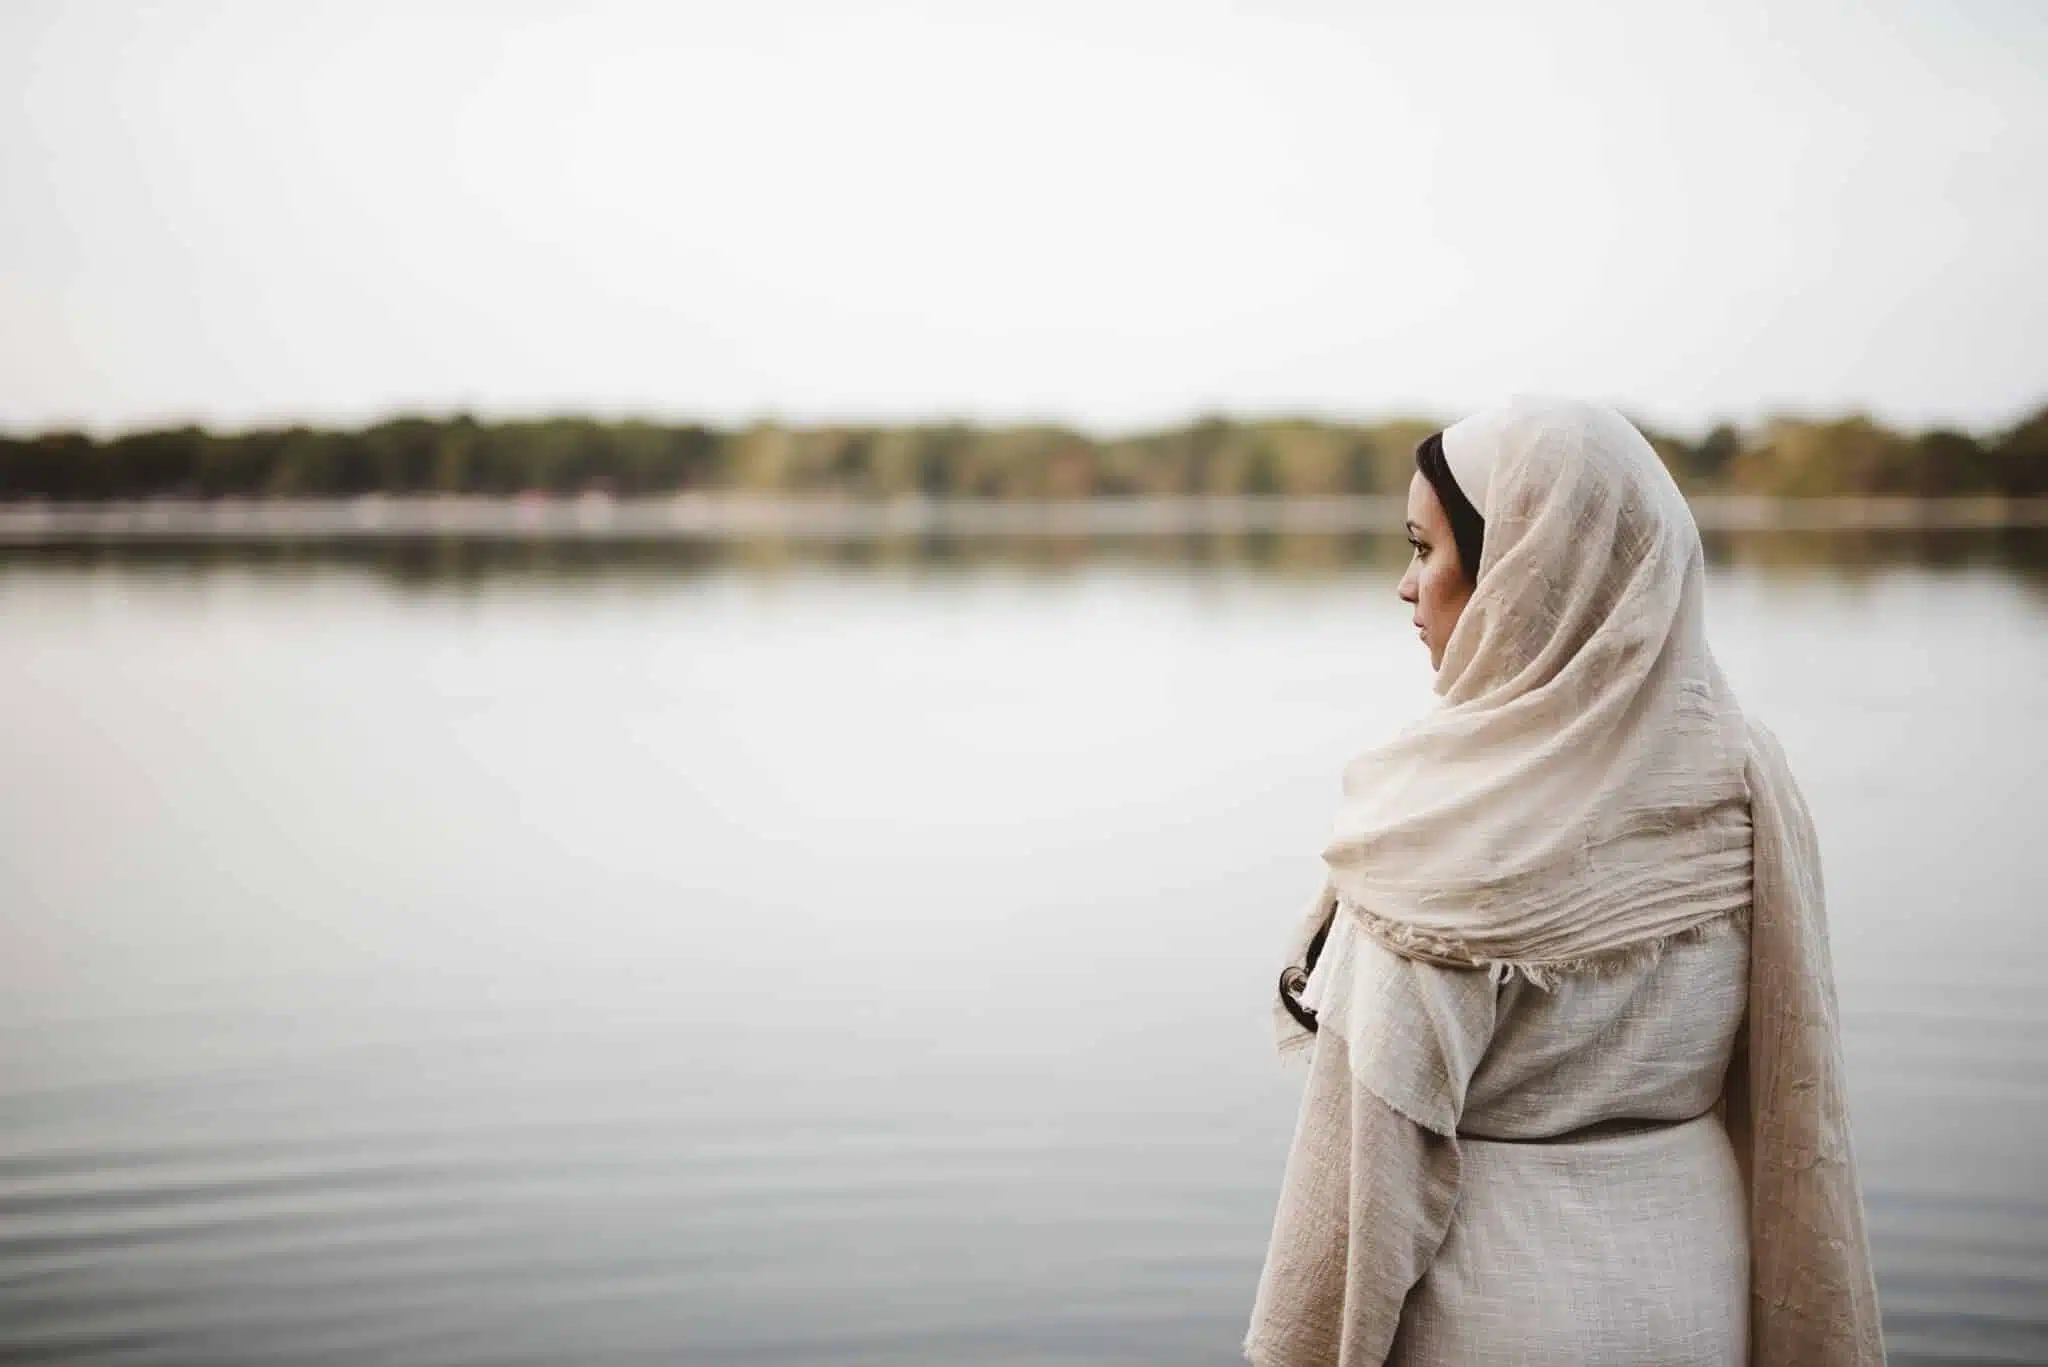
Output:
top-left (1245, 398), bottom-right (1884, 1367)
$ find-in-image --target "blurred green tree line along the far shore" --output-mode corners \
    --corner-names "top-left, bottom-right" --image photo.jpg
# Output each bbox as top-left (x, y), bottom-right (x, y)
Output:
top-left (0, 406), bottom-right (2048, 500)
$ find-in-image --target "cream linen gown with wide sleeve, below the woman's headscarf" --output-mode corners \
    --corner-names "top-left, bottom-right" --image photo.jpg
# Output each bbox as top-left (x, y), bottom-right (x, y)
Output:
top-left (1245, 906), bottom-right (1749, 1367)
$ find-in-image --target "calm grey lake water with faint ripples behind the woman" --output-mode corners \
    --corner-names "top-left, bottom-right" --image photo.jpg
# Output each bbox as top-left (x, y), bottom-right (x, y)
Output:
top-left (0, 545), bottom-right (2048, 1367)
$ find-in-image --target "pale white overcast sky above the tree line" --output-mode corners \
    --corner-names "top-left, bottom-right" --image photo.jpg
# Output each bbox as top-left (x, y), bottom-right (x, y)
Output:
top-left (0, 0), bottom-right (2048, 430)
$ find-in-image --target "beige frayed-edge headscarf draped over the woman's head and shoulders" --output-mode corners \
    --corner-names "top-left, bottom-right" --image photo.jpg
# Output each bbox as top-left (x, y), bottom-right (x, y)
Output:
top-left (1276, 398), bottom-right (1884, 1367)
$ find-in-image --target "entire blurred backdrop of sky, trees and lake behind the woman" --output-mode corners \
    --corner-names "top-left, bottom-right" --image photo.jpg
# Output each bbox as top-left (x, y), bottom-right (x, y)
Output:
top-left (0, 0), bottom-right (2048, 1367)
